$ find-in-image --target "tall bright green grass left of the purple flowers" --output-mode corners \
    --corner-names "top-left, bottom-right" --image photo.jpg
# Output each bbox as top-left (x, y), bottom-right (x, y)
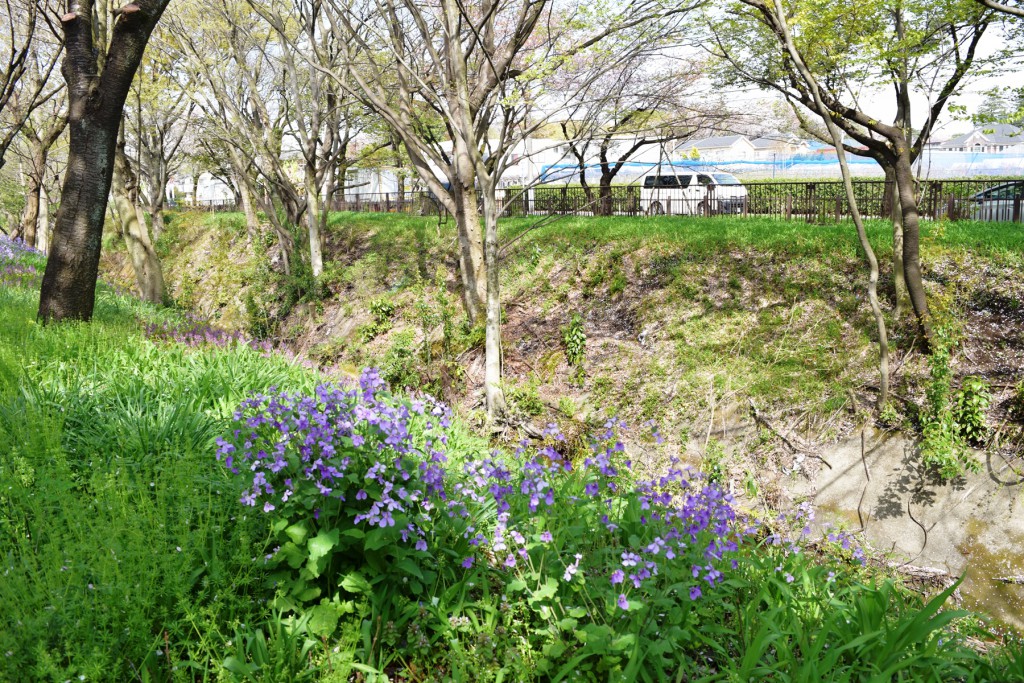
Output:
top-left (0, 289), bottom-right (314, 681)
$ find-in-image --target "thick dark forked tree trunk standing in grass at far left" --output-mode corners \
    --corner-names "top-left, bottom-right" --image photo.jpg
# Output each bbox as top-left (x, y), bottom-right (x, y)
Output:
top-left (39, 0), bottom-right (169, 323)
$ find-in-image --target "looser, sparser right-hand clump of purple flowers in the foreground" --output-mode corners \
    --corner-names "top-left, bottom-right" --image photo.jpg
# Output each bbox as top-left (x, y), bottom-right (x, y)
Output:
top-left (449, 420), bottom-right (750, 609)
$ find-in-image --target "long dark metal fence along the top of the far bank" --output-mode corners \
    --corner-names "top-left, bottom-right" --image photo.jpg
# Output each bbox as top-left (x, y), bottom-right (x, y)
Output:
top-left (179, 178), bottom-right (1024, 223)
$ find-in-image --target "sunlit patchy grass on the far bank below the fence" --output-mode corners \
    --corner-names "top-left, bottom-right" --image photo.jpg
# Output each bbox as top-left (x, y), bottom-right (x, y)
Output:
top-left (123, 213), bottom-right (1024, 454)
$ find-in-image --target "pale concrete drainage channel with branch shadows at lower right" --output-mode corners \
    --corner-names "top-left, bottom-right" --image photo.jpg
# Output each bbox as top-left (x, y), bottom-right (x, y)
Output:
top-left (786, 427), bottom-right (1024, 629)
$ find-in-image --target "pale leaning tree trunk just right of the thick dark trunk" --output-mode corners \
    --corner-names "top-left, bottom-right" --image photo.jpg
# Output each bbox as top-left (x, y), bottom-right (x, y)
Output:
top-left (112, 150), bottom-right (164, 304)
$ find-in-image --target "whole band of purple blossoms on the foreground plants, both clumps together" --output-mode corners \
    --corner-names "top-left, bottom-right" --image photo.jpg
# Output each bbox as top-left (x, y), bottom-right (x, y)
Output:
top-left (217, 370), bottom-right (753, 609)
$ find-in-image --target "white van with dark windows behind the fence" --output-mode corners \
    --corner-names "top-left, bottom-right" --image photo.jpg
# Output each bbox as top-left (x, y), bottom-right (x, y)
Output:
top-left (640, 169), bottom-right (746, 216)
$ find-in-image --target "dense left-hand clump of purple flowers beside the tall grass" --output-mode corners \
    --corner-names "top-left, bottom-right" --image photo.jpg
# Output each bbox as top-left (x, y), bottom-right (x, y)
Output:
top-left (217, 370), bottom-right (451, 550)
